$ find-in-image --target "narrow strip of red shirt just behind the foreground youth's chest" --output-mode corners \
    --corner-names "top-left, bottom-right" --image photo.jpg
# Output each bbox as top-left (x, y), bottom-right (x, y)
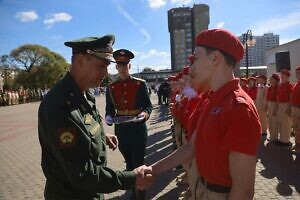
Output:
top-left (186, 92), bottom-right (209, 141)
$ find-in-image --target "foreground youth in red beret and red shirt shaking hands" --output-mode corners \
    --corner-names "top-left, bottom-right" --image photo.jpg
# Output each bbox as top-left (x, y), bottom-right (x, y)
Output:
top-left (144, 29), bottom-right (261, 200)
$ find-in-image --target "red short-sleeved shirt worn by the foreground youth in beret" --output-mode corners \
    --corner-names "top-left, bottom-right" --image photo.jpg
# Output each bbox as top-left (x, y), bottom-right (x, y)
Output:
top-left (195, 79), bottom-right (261, 186)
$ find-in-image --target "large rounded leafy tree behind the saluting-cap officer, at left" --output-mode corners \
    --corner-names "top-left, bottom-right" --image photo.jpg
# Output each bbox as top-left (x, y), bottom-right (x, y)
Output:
top-left (10, 45), bottom-right (69, 88)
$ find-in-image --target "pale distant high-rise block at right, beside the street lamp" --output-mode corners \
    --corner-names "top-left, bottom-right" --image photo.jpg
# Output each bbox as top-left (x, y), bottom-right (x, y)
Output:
top-left (240, 33), bottom-right (279, 67)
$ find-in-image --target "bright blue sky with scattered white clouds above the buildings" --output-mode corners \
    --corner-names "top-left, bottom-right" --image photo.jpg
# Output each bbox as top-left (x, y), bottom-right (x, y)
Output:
top-left (0, 0), bottom-right (300, 73)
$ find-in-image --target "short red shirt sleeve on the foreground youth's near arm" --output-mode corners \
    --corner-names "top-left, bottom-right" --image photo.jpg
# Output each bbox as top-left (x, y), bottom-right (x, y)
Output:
top-left (220, 104), bottom-right (261, 156)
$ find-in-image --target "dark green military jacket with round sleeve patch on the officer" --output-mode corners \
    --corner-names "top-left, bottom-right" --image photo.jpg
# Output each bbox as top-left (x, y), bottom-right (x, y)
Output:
top-left (38, 73), bottom-right (135, 200)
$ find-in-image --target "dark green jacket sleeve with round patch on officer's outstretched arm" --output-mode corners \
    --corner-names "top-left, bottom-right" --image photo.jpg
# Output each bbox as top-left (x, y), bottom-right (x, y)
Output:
top-left (39, 108), bottom-right (135, 193)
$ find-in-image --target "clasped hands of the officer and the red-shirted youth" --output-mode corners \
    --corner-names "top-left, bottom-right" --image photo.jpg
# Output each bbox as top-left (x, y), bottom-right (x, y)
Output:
top-left (133, 165), bottom-right (155, 190)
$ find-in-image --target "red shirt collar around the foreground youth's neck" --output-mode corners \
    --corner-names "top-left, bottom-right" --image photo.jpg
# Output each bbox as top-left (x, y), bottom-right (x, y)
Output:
top-left (209, 79), bottom-right (239, 105)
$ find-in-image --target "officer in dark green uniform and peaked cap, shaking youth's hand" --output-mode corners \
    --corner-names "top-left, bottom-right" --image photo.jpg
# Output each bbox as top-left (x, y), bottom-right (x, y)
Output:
top-left (38, 35), bottom-right (149, 200)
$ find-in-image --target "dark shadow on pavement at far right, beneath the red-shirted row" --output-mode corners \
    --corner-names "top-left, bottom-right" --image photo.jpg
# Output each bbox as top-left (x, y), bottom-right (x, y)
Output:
top-left (258, 138), bottom-right (300, 196)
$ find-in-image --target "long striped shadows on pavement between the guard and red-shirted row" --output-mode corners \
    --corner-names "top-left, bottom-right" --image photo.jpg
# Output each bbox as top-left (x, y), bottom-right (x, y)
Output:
top-left (108, 105), bottom-right (185, 200)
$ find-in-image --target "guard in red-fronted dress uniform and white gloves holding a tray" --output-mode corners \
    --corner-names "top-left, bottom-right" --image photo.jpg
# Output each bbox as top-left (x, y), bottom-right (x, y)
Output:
top-left (106, 49), bottom-right (152, 199)
